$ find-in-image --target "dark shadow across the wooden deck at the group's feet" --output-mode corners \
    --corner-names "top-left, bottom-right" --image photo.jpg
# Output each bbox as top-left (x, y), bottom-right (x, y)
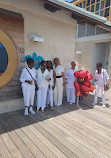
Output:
top-left (0, 95), bottom-right (109, 134)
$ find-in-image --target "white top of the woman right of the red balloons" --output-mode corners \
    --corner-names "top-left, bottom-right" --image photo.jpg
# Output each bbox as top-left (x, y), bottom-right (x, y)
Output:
top-left (94, 69), bottom-right (109, 86)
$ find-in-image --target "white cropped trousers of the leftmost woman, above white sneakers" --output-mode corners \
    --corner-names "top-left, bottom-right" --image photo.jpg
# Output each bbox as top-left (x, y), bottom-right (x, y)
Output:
top-left (22, 87), bottom-right (35, 107)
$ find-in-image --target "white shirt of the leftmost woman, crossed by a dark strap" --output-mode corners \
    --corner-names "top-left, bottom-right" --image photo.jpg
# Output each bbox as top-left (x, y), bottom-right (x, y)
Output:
top-left (20, 67), bottom-right (36, 89)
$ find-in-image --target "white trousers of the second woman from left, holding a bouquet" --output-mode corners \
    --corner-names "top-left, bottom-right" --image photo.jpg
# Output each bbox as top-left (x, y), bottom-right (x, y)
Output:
top-left (36, 87), bottom-right (47, 110)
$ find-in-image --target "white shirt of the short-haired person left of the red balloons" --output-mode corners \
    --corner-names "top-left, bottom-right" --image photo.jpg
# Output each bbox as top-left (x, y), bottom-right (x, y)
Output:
top-left (65, 69), bottom-right (77, 88)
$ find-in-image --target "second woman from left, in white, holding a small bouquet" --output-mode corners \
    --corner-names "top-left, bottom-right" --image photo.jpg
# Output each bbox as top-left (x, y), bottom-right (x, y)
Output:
top-left (36, 61), bottom-right (50, 111)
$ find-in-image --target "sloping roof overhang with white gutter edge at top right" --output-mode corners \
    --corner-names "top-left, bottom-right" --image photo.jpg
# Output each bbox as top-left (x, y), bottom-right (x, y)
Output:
top-left (43, 0), bottom-right (111, 31)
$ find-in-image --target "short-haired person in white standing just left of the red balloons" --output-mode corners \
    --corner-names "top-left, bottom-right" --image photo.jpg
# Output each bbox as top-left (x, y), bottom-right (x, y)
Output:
top-left (65, 62), bottom-right (77, 104)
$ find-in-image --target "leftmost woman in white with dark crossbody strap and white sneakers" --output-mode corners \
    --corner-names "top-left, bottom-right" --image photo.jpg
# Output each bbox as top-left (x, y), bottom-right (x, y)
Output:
top-left (20, 58), bottom-right (36, 115)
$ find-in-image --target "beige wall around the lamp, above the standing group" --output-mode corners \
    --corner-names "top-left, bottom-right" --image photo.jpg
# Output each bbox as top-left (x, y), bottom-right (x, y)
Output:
top-left (24, 13), bottom-right (75, 70)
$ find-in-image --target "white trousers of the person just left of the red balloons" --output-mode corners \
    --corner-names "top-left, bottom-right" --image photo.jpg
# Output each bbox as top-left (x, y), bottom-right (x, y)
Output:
top-left (66, 87), bottom-right (76, 103)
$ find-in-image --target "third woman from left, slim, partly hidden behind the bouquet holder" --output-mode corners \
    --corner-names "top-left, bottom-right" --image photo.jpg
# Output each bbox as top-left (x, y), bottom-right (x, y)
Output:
top-left (47, 61), bottom-right (56, 109)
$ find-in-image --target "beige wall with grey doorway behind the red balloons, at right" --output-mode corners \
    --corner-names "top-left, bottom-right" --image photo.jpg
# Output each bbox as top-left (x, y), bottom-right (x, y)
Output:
top-left (75, 35), bottom-right (111, 87)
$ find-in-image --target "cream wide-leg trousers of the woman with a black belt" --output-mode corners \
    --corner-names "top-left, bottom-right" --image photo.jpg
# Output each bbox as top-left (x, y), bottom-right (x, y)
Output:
top-left (54, 77), bottom-right (63, 106)
